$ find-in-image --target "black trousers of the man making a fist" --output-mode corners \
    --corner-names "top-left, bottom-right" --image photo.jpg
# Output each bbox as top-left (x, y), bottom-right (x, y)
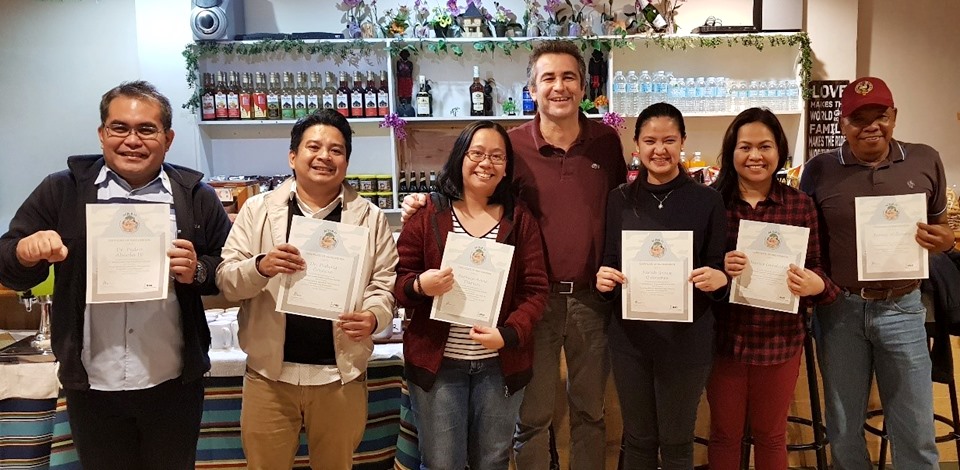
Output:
top-left (63, 378), bottom-right (203, 470)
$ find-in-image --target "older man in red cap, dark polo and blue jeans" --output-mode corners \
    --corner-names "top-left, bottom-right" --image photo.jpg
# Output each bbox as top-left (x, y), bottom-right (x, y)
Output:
top-left (800, 77), bottom-right (954, 470)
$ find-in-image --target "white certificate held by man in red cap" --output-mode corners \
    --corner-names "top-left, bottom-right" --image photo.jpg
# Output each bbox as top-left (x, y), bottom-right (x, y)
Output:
top-left (855, 193), bottom-right (930, 281)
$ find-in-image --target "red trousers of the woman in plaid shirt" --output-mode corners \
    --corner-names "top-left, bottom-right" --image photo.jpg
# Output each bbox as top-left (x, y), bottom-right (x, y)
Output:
top-left (707, 352), bottom-right (800, 470)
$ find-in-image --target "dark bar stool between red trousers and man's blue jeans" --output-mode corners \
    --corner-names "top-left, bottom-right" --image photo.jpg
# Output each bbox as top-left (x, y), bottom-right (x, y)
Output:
top-left (740, 328), bottom-right (827, 470)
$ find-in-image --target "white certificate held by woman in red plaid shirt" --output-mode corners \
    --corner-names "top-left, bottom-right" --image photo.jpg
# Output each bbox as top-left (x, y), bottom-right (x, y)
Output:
top-left (730, 220), bottom-right (810, 313)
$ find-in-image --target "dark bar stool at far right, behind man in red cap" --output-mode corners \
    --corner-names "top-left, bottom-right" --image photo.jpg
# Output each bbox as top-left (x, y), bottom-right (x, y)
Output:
top-left (863, 322), bottom-right (960, 470)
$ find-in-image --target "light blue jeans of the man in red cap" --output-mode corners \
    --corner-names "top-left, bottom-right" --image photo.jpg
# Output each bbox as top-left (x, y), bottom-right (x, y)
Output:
top-left (814, 289), bottom-right (940, 470)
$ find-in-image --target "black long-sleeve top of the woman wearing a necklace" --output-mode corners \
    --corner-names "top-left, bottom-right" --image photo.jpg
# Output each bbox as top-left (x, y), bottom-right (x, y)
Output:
top-left (603, 172), bottom-right (729, 364)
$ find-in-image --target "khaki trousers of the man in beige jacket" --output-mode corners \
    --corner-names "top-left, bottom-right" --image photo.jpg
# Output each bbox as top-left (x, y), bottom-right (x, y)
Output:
top-left (240, 369), bottom-right (367, 470)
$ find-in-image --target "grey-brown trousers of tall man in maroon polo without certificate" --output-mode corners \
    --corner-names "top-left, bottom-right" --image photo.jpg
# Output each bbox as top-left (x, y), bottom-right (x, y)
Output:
top-left (513, 289), bottom-right (610, 470)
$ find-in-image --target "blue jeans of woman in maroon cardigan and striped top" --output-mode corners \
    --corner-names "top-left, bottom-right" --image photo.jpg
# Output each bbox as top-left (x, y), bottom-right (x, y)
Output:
top-left (410, 357), bottom-right (523, 470)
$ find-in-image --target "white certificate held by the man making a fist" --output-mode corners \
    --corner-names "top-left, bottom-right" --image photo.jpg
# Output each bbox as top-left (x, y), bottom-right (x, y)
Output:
top-left (86, 204), bottom-right (172, 304)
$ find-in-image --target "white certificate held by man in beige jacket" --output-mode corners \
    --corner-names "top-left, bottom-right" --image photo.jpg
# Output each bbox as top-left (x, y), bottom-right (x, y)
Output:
top-left (277, 217), bottom-right (370, 320)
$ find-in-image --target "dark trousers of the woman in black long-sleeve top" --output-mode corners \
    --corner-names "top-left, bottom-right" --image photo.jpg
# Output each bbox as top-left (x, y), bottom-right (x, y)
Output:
top-left (609, 325), bottom-right (711, 470)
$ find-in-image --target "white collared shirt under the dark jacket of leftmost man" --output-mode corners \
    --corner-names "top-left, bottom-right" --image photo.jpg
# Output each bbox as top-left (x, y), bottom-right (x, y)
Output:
top-left (80, 165), bottom-right (183, 391)
